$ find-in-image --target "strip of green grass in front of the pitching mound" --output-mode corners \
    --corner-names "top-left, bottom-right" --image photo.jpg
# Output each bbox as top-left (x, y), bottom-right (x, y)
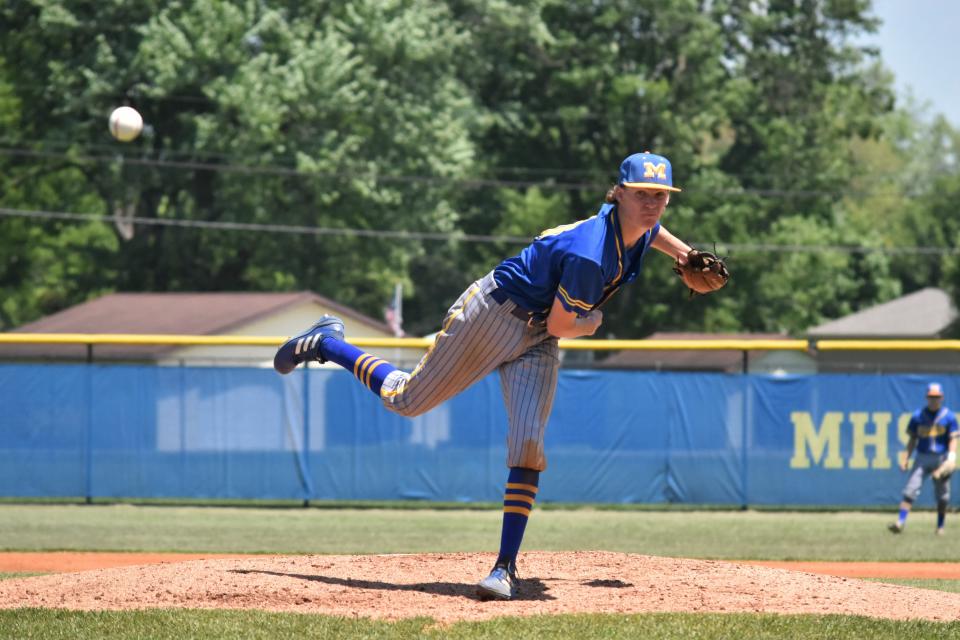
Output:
top-left (0, 609), bottom-right (960, 640)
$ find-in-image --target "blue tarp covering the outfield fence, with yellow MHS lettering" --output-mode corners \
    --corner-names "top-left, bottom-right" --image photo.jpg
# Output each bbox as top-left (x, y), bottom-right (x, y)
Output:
top-left (0, 364), bottom-right (960, 505)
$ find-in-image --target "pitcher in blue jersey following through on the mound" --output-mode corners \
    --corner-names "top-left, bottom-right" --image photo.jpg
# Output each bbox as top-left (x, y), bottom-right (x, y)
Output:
top-left (274, 152), bottom-right (728, 599)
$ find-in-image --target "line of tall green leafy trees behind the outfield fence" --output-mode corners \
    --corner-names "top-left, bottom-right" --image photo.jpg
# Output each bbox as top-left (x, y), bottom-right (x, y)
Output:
top-left (0, 0), bottom-right (960, 337)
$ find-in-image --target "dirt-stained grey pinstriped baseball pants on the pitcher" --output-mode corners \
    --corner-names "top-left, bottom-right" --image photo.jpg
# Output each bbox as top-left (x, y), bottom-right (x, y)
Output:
top-left (380, 271), bottom-right (560, 471)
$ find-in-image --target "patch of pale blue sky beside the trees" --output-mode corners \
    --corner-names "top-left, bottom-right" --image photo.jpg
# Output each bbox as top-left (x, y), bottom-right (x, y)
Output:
top-left (865, 0), bottom-right (960, 127)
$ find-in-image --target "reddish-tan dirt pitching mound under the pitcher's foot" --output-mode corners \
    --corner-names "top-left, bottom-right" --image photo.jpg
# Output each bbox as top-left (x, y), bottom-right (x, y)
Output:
top-left (0, 552), bottom-right (960, 622)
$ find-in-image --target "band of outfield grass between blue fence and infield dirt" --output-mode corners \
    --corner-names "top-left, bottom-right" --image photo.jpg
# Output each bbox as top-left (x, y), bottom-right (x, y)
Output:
top-left (0, 505), bottom-right (960, 562)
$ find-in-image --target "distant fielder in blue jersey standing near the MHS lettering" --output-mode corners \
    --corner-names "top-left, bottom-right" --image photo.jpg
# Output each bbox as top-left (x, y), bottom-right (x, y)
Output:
top-left (889, 382), bottom-right (960, 535)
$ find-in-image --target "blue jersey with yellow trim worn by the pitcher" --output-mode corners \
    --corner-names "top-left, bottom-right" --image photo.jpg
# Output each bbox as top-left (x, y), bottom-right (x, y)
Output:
top-left (493, 204), bottom-right (660, 316)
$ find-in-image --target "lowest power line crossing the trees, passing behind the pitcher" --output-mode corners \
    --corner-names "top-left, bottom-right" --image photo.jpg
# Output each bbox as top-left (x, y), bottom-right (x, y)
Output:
top-left (0, 207), bottom-right (960, 257)
